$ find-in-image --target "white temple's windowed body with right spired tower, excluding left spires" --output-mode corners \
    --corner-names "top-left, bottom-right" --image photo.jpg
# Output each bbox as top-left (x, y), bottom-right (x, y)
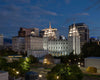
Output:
top-left (43, 25), bottom-right (80, 56)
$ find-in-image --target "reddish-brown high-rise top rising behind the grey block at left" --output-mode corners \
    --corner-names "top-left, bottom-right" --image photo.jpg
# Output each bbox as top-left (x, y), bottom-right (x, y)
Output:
top-left (18, 28), bottom-right (39, 37)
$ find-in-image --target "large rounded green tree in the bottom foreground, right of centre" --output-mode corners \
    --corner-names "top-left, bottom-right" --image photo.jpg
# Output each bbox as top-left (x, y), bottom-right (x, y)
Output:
top-left (47, 64), bottom-right (83, 80)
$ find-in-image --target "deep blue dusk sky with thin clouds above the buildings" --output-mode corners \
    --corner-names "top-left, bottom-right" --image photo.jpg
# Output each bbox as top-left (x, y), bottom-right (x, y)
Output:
top-left (0, 0), bottom-right (100, 38)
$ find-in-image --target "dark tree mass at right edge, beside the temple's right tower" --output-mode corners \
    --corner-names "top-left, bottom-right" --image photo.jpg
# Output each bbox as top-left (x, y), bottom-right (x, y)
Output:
top-left (81, 42), bottom-right (100, 57)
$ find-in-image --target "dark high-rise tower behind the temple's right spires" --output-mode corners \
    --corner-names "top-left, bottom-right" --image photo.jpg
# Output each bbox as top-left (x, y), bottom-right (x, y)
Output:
top-left (69, 23), bottom-right (89, 47)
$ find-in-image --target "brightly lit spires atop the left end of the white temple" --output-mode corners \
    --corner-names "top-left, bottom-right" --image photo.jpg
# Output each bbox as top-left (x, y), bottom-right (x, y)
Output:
top-left (41, 24), bottom-right (59, 39)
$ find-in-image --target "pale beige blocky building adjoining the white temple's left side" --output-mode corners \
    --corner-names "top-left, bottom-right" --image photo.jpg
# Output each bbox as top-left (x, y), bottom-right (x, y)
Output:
top-left (25, 36), bottom-right (48, 58)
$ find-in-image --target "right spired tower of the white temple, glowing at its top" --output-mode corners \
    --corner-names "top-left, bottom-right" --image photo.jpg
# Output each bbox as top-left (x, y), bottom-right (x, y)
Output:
top-left (68, 24), bottom-right (80, 54)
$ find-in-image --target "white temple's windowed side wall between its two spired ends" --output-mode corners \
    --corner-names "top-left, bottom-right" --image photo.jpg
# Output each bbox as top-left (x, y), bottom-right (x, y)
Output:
top-left (43, 38), bottom-right (68, 56)
